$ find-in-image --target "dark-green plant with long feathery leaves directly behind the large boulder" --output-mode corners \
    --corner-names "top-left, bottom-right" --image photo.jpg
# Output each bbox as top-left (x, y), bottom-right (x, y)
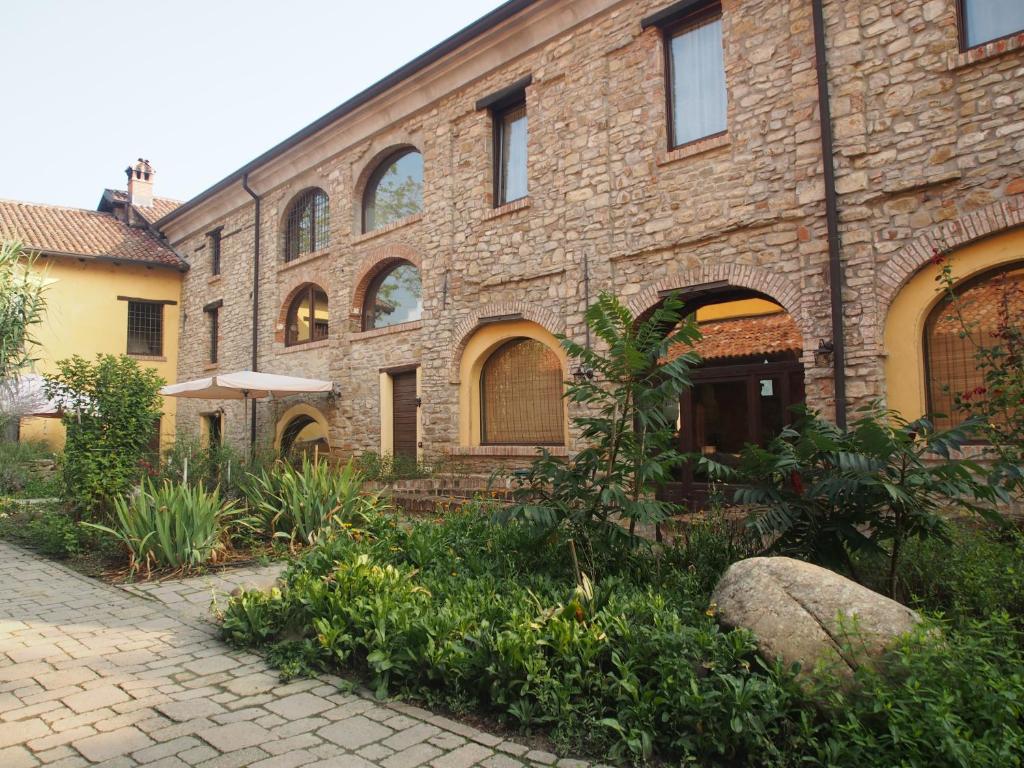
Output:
top-left (720, 407), bottom-right (1006, 595)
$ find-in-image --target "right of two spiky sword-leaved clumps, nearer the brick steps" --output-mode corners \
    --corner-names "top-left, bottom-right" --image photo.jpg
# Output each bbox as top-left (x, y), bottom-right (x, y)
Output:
top-left (245, 457), bottom-right (381, 545)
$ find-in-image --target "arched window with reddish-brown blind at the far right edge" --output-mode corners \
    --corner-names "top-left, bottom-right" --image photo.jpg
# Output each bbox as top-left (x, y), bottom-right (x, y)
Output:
top-left (925, 262), bottom-right (1024, 428)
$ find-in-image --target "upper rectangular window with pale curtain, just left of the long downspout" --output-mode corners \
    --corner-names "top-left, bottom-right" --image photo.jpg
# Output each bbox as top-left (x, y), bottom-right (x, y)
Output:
top-left (666, 8), bottom-right (727, 147)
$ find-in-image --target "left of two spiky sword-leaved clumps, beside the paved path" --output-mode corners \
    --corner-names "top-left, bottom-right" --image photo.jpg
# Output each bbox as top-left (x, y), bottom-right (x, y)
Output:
top-left (85, 481), bottom-right (237, 572)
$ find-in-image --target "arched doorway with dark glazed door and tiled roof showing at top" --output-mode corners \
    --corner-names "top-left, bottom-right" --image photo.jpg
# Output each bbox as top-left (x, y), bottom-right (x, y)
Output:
top-left (664, 288), bottom-right (805, 507)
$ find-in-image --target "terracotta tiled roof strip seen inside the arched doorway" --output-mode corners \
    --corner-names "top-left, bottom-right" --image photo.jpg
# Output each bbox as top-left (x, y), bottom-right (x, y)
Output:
top-left (670, 312), bottom-right (803, 360)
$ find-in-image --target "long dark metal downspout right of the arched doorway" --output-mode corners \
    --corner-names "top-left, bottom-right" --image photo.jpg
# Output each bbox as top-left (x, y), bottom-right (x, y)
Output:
top-left (811, 0), bottom-right (846, 429)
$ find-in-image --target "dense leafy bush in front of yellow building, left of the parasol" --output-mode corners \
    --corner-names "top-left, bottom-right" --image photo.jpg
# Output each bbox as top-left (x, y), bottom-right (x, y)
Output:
top-left (46, 354), bottom-right (164, 517)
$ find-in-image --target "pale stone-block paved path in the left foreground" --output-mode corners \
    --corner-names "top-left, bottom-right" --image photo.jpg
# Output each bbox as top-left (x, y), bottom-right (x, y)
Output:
top-left (0, 543), bottom-right (584, 768)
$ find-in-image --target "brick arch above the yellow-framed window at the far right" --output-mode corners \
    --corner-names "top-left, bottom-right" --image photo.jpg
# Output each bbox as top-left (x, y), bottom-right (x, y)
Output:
top-left (878, 197), bottom-right (1024, 324)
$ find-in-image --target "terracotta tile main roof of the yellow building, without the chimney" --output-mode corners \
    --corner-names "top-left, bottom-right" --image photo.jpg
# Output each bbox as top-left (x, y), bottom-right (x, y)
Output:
top-left (0, 200), bottom-right (185, 269)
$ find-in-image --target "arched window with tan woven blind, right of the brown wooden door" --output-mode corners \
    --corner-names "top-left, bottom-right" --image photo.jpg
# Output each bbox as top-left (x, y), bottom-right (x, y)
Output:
top-left (480, 338), bottom-right (565, 445)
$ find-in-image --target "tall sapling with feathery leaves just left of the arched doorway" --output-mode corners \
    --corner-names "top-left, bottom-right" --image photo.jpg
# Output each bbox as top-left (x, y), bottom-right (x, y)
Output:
top-left (500, 293), bottom-right (700, 566)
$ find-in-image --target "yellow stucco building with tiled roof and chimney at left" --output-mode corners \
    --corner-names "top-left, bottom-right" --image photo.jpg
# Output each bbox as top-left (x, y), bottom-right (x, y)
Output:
top-left (0, 160), bottom-right (187, 449)
